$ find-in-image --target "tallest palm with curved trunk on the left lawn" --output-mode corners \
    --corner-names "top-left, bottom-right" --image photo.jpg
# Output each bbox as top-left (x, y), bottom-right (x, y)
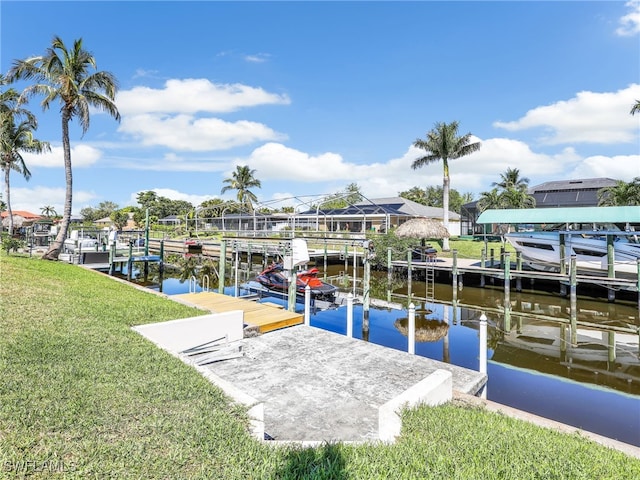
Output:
top-left (7, 36), bottom-right (120, 260)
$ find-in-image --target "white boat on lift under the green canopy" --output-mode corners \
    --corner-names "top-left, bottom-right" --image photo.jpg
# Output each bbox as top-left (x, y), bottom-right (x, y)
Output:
top-left (505, 230), bottom-right (640, 274)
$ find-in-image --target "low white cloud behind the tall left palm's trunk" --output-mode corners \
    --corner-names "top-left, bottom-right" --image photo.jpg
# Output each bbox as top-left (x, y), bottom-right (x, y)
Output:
top-left (11, 186), bottom-right (97, 215)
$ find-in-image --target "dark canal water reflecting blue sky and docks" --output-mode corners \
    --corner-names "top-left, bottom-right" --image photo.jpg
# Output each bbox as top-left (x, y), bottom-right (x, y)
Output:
top-left (141, 268), bottom-right (640, 446)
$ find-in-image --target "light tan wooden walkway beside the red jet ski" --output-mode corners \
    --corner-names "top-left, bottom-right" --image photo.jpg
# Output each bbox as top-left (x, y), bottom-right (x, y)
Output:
top-left (171, 292), bottom-right (304, 333)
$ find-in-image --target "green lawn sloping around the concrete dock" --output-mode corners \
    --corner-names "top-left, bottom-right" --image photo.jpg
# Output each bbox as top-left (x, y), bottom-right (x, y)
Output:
top-left (0, 254), bottom-right (640, 479)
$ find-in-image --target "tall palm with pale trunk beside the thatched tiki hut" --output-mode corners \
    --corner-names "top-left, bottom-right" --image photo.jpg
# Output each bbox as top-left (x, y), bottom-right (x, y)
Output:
top-left (411, 122), bottom-right (480, 251)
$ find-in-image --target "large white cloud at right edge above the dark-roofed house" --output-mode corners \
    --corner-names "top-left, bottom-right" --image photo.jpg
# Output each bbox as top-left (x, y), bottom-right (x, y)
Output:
top-left (494, 84), bottom-right (640, 145)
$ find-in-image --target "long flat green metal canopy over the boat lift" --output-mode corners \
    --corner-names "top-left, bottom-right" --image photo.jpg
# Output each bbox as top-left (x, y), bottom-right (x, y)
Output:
top-left (476, 206), bottom-right (640, 224)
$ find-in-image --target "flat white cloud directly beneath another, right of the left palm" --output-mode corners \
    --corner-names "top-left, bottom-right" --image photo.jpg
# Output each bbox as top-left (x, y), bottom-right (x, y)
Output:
top-left (118, 114), bottom-right (285, 151)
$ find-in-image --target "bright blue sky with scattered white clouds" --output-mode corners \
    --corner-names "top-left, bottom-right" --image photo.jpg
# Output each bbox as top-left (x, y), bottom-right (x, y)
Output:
top-left (0, 0), bottom-right (640, 213)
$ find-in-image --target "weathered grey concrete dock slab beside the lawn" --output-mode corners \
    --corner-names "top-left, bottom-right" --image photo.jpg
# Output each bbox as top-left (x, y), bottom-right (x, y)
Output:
top-left (200, 325), bottom-right (486, 441)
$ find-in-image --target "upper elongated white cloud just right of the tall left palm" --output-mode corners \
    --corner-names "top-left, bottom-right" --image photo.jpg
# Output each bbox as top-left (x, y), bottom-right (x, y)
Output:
top-left (116, 78), bottom-right (290, 117)
